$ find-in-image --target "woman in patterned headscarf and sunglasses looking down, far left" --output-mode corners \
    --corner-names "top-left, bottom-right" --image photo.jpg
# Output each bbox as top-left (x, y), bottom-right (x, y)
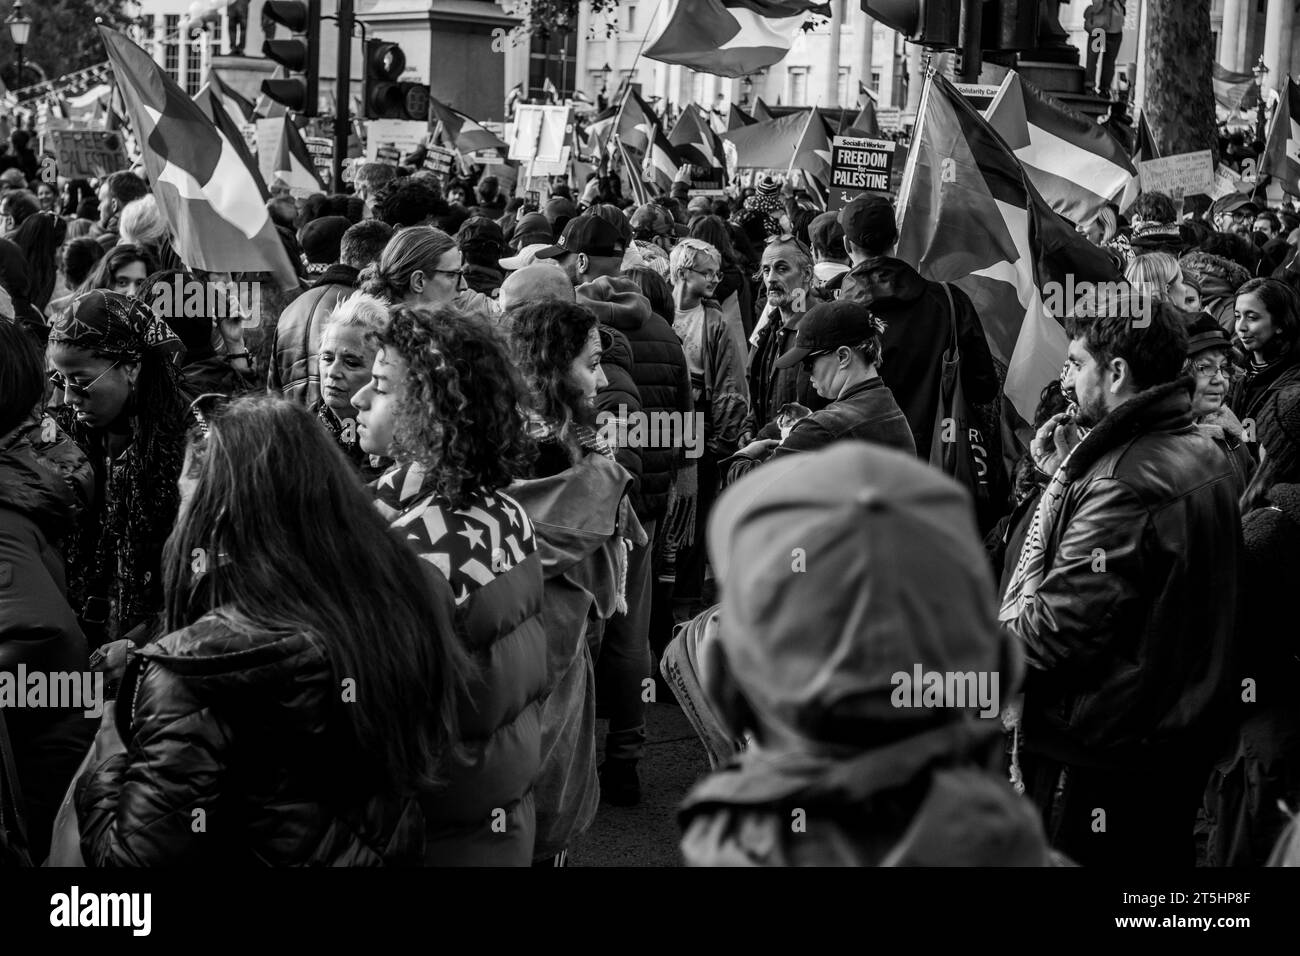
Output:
top-left (47, 290), bottom-right (189, 646)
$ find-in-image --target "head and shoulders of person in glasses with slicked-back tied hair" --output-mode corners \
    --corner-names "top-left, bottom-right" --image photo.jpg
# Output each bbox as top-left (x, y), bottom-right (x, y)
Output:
top-left (359, 226), bottom-right (495, 317)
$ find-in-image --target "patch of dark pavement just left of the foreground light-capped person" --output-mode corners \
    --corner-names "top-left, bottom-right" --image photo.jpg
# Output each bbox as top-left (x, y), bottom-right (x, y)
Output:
top-left (569, 704), bottom-right (709, 866)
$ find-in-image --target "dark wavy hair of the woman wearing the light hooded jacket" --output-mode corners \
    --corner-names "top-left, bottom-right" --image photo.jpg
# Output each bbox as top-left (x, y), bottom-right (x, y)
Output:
top-left (511, 299), bottom-right (595, 457)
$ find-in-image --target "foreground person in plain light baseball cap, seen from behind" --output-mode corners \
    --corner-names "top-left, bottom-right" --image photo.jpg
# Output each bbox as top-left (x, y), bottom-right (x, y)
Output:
top-left (680, 441), bottom-right (1054, 866)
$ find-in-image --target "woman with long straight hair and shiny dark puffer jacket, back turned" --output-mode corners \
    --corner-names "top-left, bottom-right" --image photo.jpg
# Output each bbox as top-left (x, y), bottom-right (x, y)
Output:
top-left (75, 395), bottom-right (473, 868)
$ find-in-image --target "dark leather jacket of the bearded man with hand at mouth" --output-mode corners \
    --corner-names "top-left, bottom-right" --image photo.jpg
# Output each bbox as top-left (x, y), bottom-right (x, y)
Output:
top-left (1004, 378), bottom-right (1242, 770)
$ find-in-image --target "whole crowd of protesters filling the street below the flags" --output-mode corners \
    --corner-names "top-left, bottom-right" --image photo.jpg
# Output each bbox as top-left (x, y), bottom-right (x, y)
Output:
top-left (0, 123), bottom-right (1300, 866)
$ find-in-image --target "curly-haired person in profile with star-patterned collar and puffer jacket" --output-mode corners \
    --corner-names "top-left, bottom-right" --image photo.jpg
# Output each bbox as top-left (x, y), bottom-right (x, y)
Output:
top-left (351, 306), bottom-right (546, 866)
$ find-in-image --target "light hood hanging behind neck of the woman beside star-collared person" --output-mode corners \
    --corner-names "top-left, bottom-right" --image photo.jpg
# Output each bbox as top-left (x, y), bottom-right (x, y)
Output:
top-left (506, 453), bottom-right (632, 578)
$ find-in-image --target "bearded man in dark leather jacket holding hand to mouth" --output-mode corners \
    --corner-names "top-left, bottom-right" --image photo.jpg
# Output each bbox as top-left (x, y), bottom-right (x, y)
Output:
top-left (998, 295), bottom-right (1242, 868)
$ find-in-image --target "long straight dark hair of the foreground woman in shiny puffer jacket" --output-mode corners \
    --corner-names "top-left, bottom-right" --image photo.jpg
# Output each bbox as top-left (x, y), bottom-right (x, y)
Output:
top-left (163, 395), bottom-right (469, 793)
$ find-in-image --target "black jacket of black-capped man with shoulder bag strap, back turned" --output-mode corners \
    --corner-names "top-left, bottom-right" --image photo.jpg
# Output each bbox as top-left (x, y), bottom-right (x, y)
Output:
top-left (840, 256), bottom-right (998, 458)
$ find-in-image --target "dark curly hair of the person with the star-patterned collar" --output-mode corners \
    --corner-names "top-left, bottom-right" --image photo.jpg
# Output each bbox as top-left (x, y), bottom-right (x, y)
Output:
top-left (380, 306), bottom-right (532, 509)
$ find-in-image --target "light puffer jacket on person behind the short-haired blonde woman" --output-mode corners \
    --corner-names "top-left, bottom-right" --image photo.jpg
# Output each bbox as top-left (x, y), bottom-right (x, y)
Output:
top-left (267, 263), bottom-right (358, 408)
